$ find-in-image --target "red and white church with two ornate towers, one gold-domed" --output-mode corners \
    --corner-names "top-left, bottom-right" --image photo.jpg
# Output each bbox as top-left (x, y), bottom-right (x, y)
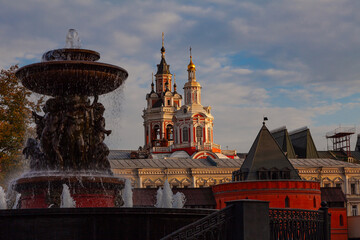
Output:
top-left (142, 35), bottom-right (222, 159)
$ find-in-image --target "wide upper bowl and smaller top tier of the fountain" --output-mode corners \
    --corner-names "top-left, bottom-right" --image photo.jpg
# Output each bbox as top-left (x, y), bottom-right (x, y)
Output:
top-left (16, 48), bottom-right (128, 96)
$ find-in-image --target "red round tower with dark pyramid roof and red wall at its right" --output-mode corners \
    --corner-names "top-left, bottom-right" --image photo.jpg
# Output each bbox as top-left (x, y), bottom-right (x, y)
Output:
top-left (212, 123), bottom-right (347, 240)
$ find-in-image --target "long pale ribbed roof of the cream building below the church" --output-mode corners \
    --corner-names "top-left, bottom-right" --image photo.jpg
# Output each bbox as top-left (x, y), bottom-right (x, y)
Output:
top-left (110, 158), bottom-right (360, 169)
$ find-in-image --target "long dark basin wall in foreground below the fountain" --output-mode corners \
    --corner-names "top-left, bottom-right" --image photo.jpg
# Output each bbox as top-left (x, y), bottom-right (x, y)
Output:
top-left (0, 208), bottom-right (215, 240)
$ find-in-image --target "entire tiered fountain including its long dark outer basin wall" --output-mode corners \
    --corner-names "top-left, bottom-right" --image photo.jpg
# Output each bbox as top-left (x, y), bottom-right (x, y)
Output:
top-left (0, 30), bottom-right (214, 240)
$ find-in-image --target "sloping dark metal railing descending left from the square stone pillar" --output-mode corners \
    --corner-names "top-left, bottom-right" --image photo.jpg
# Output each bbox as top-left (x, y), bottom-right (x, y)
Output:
top-left (161, 205), bottom-right (233, 240)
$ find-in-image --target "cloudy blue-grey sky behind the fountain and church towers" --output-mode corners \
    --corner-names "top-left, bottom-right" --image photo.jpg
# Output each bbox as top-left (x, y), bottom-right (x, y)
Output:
top-left (0, 0), bottom-right (360, 152)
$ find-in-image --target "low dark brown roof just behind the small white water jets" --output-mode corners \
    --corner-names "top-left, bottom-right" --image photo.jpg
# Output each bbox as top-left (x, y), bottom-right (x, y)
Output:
top-left (133, 188), bottom-right (216, 208)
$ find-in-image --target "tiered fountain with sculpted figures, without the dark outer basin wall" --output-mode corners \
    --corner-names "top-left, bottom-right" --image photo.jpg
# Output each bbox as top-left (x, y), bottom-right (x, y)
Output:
top-left (13, 29), bottom-right (128, 208)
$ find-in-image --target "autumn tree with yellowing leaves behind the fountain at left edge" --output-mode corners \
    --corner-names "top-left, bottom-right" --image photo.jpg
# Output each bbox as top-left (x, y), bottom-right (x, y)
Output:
top-left (0, 65), bottom-right (42, 183)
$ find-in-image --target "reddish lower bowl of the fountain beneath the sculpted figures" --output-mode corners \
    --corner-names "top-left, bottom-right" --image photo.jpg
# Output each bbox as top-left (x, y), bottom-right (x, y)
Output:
top-left (14, 174), bottom-right (125, 209)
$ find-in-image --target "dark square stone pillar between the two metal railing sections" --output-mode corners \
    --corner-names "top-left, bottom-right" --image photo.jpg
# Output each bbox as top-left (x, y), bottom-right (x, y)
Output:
top-left (225, 199), bottom-right (270, 240)
